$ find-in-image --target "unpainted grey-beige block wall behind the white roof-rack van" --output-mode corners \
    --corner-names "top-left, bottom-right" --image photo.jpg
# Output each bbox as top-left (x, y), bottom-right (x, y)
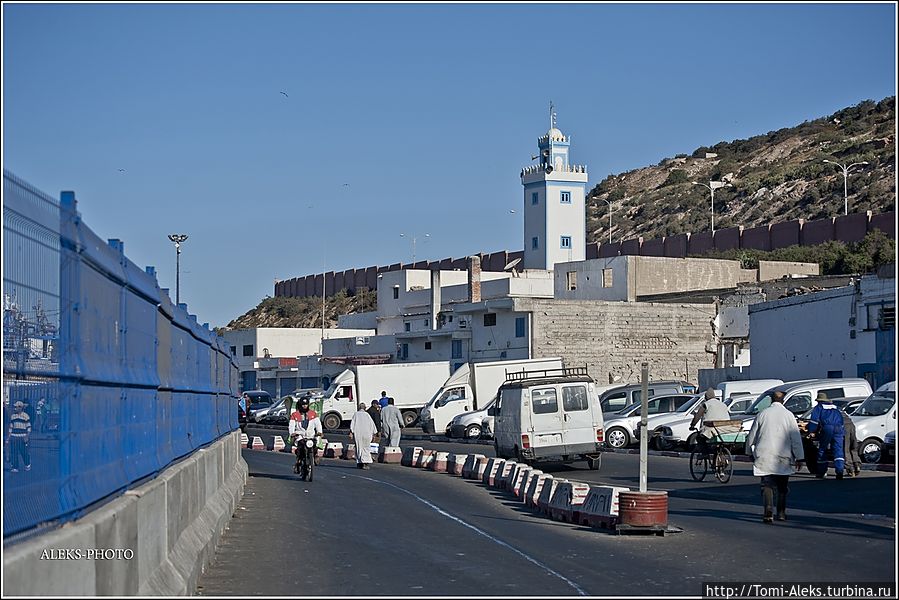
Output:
top-left (515, 298), bottom-right (715, 384)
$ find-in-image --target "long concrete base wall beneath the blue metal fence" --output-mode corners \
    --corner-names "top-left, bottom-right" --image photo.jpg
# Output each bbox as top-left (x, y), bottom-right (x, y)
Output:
top-left (3, 431), bottom-right (247, 597)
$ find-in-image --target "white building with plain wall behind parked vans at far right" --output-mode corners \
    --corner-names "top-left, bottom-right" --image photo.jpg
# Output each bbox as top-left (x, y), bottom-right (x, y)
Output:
top-left (749, 271), bottom-right (896, 387)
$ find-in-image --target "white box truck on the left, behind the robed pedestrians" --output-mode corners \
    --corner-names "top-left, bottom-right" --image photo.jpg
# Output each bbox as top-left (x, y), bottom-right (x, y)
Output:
top-left (320, 361), bottom-right (449, 431)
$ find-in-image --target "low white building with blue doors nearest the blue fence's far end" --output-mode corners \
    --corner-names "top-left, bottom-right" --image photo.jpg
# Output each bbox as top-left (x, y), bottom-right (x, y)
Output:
top-left (222, 327), bottom-right (375, 397)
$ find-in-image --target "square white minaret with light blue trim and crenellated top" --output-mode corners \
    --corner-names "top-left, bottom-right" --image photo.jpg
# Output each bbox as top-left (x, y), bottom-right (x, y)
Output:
top-left (521, 102), bottom-right (587, 270)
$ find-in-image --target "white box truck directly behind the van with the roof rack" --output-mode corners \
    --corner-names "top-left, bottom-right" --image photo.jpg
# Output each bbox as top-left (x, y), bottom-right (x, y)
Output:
top-left (420, 358), bottom-right (565, 433)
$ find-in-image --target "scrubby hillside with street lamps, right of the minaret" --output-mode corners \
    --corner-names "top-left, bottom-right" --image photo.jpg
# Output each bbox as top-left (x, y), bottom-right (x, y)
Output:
top-left (587, 97), bottom-right (896, 242)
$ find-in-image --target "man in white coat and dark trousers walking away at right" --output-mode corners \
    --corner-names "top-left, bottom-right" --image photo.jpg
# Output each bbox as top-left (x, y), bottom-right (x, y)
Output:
top-left (746, 391), bottom-right (805, 523)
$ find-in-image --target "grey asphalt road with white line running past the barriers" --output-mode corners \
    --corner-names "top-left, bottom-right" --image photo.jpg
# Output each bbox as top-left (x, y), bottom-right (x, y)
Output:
top-left (197, 428), bottom-right (896, 596)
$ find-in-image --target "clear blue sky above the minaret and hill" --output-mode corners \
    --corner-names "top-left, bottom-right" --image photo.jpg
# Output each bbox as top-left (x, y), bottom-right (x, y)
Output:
top-left (3, 3), bottom-right (896, 325)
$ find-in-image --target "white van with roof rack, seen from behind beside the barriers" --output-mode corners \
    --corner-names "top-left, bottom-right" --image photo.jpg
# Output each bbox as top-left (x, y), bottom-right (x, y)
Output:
top-left (490, 367), bottom-right (603, 470)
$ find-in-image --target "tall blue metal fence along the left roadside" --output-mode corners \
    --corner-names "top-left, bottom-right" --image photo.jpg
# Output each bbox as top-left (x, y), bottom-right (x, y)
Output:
top-left (3, 171), bottom-right (238, 539)
